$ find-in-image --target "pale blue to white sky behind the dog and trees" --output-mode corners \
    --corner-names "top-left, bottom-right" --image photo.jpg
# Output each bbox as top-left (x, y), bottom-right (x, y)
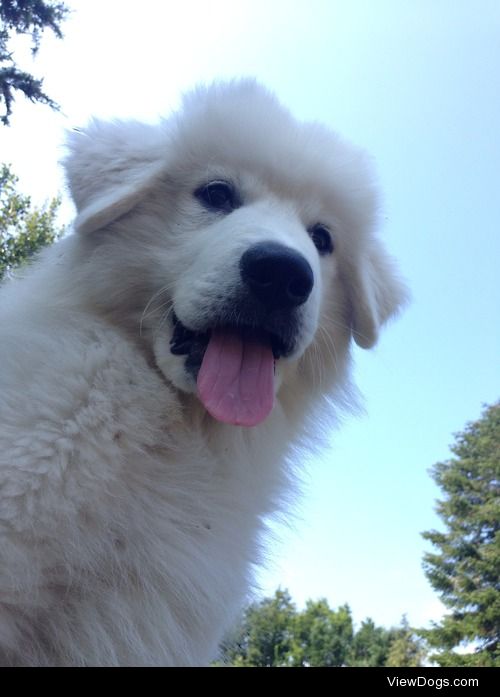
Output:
top-left (0, 0), bottom-right (500, 626)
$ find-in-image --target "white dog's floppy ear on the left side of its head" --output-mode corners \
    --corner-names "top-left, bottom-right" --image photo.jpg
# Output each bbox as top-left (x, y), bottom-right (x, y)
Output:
top-left (64, 120), bottom-right (167, 233)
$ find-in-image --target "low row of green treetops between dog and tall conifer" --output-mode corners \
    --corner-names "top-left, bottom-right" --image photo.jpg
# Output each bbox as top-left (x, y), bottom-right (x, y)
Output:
top-left (216, 589), bottom-right (425, 668)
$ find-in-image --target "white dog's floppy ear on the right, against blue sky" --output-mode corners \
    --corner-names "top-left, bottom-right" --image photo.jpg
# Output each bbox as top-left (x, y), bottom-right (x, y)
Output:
top-left (346, 240), bottom-right (409, 349)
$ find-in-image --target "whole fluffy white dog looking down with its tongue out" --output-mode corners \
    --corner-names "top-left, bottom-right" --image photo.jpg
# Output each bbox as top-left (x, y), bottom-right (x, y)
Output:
top-left (0, 81), bottom-right (404, 666)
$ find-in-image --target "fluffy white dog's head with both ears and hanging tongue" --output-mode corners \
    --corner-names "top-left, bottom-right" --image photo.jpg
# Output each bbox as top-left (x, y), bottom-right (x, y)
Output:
top-left (66, 81), bottom-right (404, 425)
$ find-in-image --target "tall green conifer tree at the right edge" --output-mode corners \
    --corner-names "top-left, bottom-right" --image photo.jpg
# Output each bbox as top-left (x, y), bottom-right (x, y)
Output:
top-left (422, 402), bottom-right (500, 666)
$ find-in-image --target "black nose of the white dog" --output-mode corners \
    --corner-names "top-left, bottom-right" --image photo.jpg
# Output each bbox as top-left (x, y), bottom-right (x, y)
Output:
top-left (240, 242), bottom-right (314, 309)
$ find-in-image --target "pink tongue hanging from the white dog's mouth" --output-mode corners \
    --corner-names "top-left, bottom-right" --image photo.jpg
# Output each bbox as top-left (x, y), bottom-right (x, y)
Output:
top-left (198, 329), bottom-right (274, 426)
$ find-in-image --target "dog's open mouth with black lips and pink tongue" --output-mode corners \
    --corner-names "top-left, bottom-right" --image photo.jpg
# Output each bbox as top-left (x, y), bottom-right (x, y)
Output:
top-left (170, 315), bottom-right (290, 426)
